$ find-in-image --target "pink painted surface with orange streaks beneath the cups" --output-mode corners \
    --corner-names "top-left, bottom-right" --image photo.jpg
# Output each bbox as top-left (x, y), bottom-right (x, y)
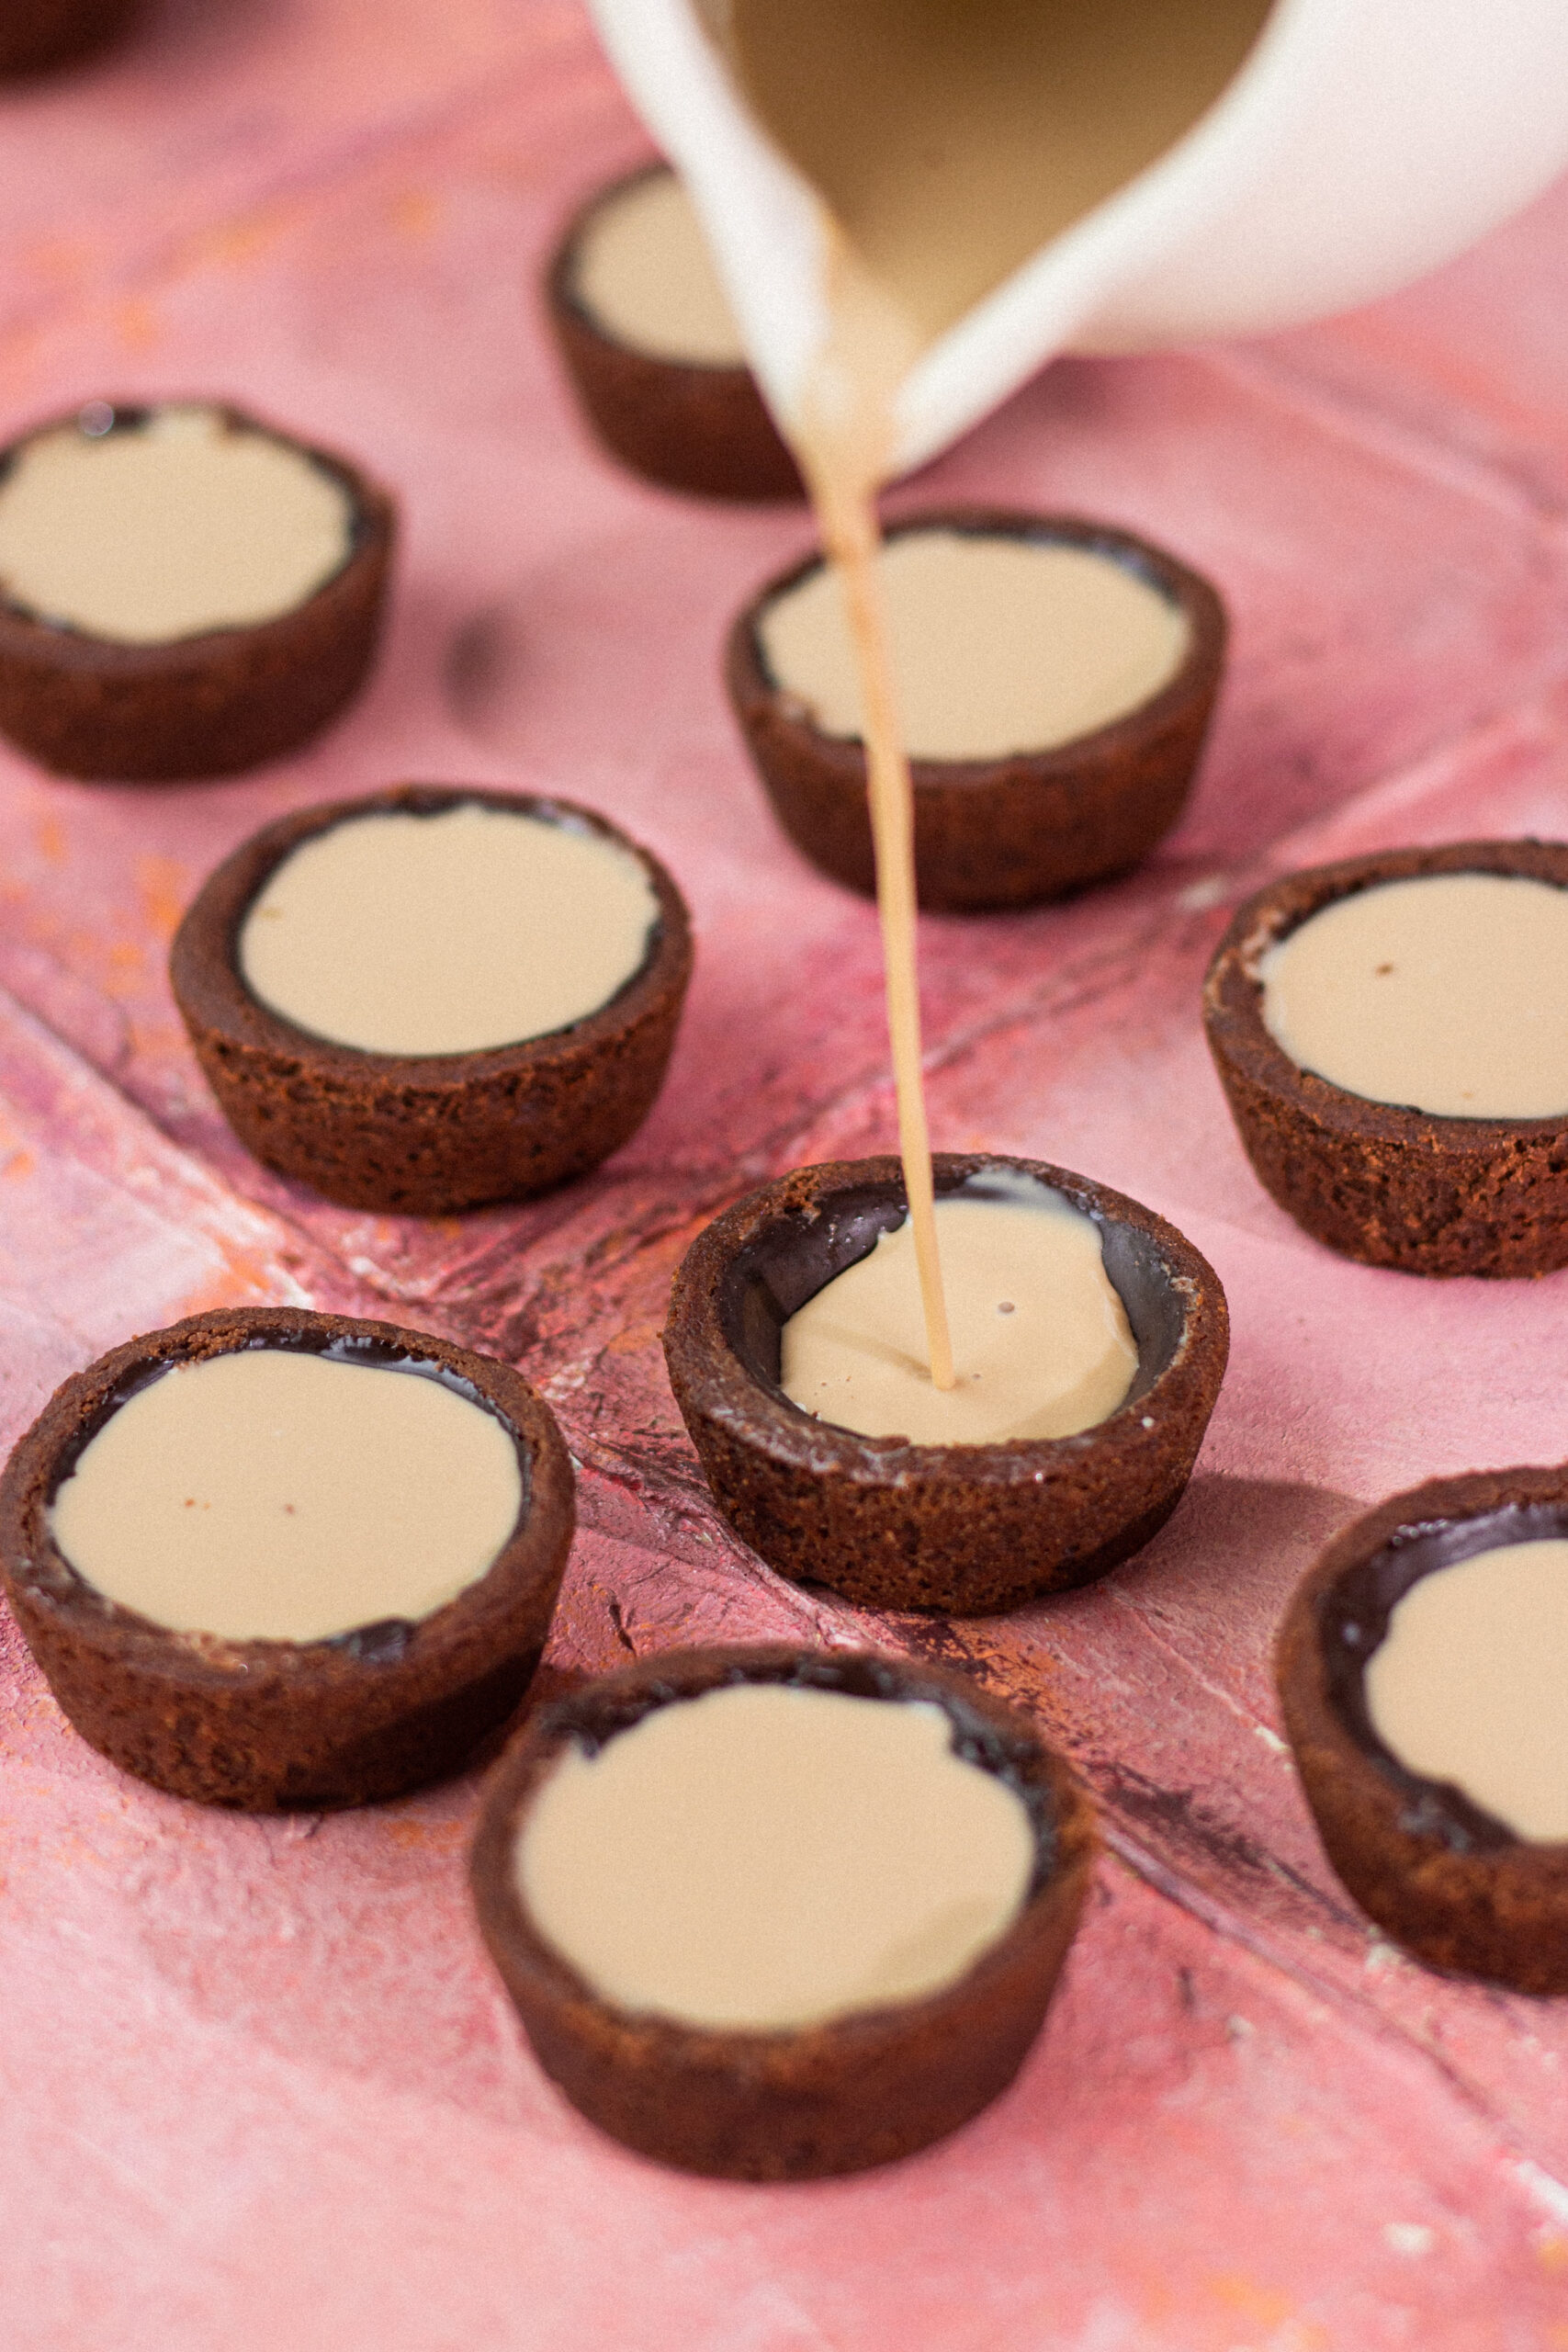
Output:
top-left (0, 0), bottom-right (1568, 2352)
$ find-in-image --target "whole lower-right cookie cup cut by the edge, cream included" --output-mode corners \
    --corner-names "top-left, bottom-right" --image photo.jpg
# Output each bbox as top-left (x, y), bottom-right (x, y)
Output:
top-left (1274, 1465), bottom-right (1568, 1992)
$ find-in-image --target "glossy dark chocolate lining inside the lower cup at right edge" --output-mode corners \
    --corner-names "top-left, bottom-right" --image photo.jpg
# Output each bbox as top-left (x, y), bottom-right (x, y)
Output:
top-left (1316, 1500), bottom-right (1568, 1853)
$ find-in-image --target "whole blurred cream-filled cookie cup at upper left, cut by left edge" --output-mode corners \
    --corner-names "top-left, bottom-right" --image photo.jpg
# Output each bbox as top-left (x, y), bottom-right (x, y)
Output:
top-left (0, 400), bottom-right (395, 783)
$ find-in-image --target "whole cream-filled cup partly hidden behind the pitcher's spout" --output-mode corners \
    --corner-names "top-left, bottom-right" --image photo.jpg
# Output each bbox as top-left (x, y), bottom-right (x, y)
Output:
top-left (546, 163), bottom-right (804, 499)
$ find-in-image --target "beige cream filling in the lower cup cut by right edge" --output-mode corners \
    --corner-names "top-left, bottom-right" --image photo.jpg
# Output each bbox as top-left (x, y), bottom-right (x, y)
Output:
top-left (1366, 1538), bottom-right (1568, 1841)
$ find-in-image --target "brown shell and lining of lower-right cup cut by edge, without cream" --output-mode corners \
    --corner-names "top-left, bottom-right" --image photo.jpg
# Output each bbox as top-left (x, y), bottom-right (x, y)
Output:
top-left (1274, 1467), bottom-right (1568, 1992)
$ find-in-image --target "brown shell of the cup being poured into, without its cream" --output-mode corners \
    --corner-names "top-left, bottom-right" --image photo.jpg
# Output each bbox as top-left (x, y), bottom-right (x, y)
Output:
top-left (665, 1152), bottom-right (1229, 1616)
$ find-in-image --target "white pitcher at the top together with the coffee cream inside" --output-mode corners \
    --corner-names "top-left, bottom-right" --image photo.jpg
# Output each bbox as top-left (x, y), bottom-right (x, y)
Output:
top-left (592, 0), bottom-right (1568, 473)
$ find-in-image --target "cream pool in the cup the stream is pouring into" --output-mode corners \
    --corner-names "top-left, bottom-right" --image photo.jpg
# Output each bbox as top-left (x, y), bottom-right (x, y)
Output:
top-left (781, 1171), bottom-right (1138, 1446)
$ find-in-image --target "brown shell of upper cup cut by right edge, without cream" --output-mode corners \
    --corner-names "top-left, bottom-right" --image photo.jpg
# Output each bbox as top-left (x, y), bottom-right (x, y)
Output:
top-left (1203, 842), bottom-right (1568, 1275)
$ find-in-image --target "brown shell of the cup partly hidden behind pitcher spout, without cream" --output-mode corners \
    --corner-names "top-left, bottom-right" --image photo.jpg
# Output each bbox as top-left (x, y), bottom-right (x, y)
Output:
top-left (546, 163), bottom-right (807, 501)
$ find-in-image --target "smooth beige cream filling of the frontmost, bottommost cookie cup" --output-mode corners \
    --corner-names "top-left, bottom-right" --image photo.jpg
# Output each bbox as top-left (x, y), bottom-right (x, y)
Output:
top-left (514, 1684), bottom-right (1034, 2032)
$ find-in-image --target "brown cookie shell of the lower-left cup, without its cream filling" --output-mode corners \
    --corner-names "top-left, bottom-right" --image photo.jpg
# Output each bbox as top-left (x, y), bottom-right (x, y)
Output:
top-left (0, 1307), bottom-right (573, 1814)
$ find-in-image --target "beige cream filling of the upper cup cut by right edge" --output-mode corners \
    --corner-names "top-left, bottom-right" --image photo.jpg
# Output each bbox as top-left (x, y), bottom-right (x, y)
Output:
top-left (1258, 873), bottom-right (1568, 1120)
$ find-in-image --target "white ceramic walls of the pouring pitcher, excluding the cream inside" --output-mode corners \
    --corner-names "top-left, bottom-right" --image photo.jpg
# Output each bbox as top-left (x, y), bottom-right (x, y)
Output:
top-left (590, 0), bottom-right (1568, 473)
